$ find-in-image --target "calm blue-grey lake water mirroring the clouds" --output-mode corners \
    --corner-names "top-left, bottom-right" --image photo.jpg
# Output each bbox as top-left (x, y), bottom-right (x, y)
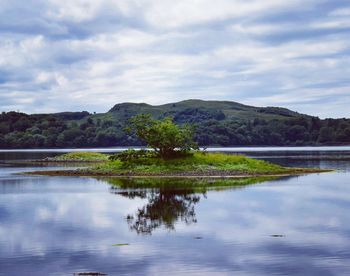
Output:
top-left (0, 147), bottom-right (350, 275)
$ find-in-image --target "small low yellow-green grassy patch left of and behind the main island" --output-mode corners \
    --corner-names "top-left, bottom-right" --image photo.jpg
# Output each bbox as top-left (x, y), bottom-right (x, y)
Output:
top-left (49, 151), bottom-right (109, 162)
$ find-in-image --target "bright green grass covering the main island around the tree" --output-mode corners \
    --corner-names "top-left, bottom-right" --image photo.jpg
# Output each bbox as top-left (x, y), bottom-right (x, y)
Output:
top-left (85, 152), bottom-right (311, 175)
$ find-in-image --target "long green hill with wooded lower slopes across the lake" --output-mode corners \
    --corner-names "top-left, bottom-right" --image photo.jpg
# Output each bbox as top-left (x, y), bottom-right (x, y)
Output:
top-left (0, 100), bottom-right (350, 148)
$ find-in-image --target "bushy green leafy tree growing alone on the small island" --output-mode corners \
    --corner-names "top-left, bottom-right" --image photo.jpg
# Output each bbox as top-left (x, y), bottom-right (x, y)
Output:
top-left (126, 114), bottom-right (199, 159)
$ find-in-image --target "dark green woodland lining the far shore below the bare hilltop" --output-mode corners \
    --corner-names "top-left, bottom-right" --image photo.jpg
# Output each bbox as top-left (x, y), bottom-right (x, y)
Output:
top-left (0, 108), bottom-right (350, 148)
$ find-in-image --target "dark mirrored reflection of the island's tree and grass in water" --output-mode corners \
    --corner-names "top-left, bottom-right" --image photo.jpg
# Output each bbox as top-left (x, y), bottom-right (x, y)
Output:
top-left (106, 177), bottom-right (274, 234)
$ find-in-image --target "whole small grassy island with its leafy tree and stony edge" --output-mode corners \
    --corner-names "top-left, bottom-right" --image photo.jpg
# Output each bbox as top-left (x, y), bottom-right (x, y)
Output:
top-left (30, 114), bottom-right (329, 178)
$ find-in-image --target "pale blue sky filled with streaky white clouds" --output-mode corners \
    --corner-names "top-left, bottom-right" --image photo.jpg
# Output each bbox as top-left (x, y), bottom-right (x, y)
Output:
top-left (0, 0), bottom-right (350, 118)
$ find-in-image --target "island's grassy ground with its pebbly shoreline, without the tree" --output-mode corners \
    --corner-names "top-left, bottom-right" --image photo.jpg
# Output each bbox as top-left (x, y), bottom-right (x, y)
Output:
top-left (28, 152), bottom-right (325, 177)
